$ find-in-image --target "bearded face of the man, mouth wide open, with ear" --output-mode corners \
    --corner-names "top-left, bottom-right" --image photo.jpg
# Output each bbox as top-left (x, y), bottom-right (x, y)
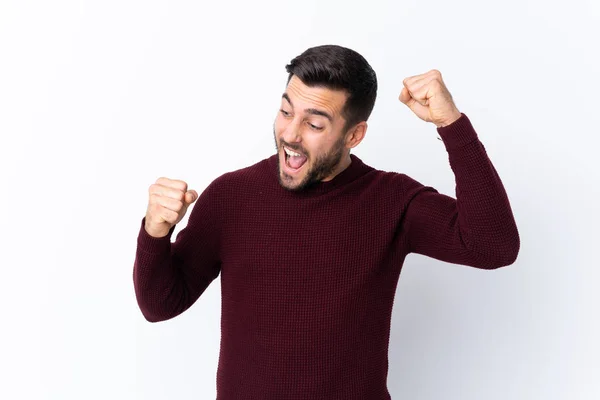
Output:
top-left (273, 75), bottom-right (366, 191)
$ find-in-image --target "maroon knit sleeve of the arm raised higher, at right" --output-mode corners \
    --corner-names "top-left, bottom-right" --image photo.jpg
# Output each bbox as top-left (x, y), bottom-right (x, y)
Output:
top-left (404, 114), bottom-right (520, 269)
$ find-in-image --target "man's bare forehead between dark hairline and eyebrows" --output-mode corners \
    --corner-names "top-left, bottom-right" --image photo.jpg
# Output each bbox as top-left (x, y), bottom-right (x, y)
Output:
top-left (282, 75), bottom-right (348, 117)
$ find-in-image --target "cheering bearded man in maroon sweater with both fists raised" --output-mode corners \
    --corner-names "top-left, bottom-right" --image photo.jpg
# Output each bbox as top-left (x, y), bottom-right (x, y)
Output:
top-left (133, 46), bottom-right (520, 400)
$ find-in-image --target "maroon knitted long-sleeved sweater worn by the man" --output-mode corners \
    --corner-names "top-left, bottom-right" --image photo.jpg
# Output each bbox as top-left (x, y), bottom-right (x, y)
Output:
top-left (133, 114), bottom-right (520, 400)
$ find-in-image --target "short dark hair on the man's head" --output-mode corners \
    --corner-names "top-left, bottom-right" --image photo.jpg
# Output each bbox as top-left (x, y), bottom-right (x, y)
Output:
top-left (285, 45), bottom-right (377, 132)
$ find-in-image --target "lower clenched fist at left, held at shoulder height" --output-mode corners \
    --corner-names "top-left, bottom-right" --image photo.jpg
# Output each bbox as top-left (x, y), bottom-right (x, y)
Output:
top-left (144, 178), bottom-right (198, 237)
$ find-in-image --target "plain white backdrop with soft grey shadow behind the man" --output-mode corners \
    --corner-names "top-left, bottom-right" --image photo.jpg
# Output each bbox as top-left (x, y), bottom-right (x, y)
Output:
top-left (0, 0), bottom-right (600, 400)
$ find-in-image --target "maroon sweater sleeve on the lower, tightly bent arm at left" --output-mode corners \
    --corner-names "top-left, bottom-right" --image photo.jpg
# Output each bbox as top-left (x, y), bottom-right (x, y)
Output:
top-left (133, 178), bottom-right (220, 322)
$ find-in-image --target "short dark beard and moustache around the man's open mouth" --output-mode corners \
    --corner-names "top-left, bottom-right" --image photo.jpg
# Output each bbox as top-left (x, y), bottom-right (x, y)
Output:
top-left (273, 129), bottom-right (345, 192)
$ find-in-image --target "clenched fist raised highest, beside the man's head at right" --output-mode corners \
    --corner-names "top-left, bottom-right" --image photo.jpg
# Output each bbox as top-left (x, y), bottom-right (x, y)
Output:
top-left (399, 69), bottom-right (461, 128)
